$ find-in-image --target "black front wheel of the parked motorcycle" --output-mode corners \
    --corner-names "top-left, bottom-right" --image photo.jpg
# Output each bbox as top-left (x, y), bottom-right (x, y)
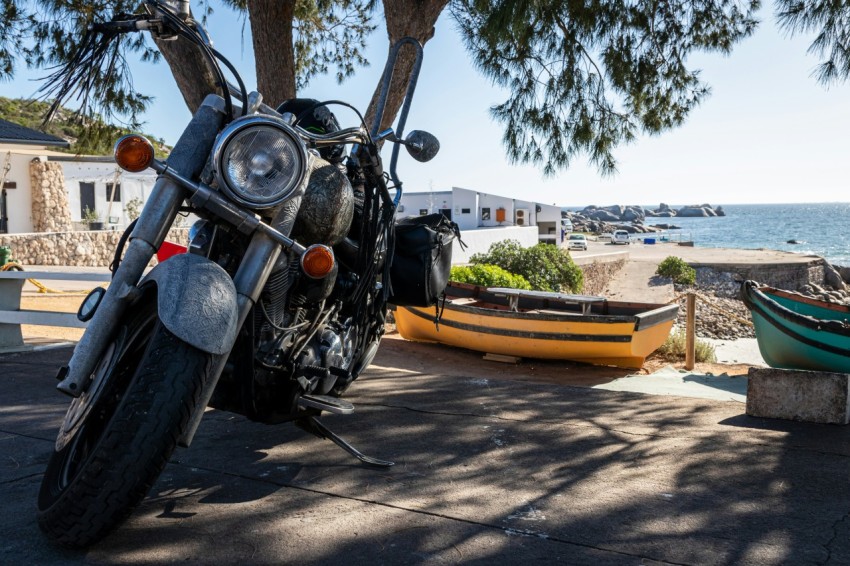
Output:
top-left (38, 297), bottom-right (212, 547)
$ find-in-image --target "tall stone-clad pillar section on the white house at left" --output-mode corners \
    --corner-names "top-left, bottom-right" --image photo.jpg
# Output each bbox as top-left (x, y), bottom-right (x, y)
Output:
top-left (30, 160), bottom-right (73, 232)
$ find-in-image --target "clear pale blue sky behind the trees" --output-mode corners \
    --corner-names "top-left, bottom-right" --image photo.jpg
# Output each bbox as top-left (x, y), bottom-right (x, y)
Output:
top-left (0, 6), bottom-right (850, 207)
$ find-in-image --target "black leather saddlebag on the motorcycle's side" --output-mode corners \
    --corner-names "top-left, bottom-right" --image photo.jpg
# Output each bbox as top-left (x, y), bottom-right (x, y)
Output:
top-left (389, 213), bottom-right (463, 307)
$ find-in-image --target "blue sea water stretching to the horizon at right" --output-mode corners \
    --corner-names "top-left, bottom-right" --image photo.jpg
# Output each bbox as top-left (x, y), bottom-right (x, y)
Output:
top-left (645, 202), bottom-right (850, 266)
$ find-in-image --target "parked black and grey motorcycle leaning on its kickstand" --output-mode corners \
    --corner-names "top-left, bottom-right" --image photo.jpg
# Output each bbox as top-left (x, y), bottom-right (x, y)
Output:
top-left (38, 0), bottom-right (448, 547)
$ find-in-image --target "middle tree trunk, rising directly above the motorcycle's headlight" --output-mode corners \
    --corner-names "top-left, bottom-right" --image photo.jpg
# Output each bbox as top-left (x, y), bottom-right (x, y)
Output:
top-left (248, 0), bottom-right (295, 108)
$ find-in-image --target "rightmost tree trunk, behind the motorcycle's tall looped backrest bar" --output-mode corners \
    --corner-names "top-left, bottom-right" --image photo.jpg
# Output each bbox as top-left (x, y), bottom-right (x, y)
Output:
top-left (366, 0), bottom-right (448, 135)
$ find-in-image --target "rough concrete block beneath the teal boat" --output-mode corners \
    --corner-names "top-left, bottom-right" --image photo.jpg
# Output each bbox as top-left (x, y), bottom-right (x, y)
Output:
top-left (747, 368), bottom-right (850, 424)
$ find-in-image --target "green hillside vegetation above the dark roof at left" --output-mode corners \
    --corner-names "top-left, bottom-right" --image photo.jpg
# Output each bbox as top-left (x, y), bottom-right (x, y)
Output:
top-left (0, 96), bottom-right (171, 157)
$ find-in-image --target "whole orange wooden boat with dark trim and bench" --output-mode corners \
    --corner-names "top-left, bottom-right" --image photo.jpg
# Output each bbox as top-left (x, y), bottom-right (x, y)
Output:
top-left (395, 283), bottom-right (678, 368)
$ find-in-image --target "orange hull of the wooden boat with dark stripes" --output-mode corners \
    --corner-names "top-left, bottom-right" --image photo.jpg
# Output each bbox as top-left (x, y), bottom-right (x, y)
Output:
top-left (395, 286), bottom-right (678, 368)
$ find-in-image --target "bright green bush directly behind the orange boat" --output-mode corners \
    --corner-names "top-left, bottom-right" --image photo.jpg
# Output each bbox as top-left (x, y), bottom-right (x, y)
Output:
top-left (470, 240), bottom-right (584, 293)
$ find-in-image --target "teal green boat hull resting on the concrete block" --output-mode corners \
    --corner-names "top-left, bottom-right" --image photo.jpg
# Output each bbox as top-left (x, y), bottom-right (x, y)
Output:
top-left (741, 281), bottom-right (850, 373)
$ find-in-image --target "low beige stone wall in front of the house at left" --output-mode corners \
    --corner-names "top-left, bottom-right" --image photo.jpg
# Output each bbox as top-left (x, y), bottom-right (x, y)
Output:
top-left (0, 228), bottom-right (189, 267)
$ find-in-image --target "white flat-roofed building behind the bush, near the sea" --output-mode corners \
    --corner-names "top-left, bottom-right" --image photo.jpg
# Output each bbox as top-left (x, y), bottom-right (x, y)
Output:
top-left (396, 187), bottom-right (564, 263)
